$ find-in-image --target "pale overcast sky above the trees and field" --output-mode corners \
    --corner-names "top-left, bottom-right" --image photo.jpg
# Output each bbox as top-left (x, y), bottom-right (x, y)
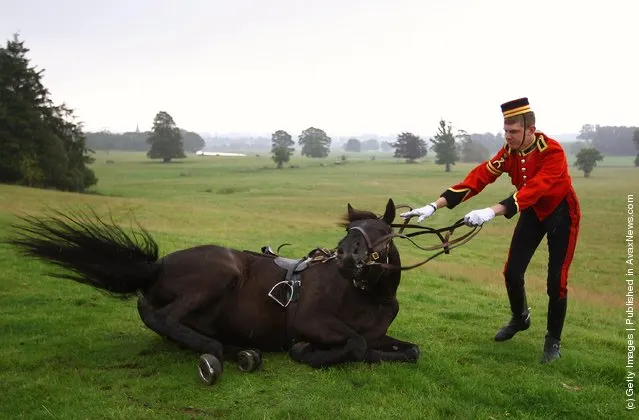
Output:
top-left (0, 0), bottom-right (639, 136)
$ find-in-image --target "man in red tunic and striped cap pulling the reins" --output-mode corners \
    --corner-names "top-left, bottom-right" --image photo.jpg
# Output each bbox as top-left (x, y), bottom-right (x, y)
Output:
top-left (401, 98), bottom-right (581, 363)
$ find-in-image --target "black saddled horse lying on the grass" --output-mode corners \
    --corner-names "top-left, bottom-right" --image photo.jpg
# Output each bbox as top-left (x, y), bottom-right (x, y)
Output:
top-left (10, 200), bottom-right (419, 383)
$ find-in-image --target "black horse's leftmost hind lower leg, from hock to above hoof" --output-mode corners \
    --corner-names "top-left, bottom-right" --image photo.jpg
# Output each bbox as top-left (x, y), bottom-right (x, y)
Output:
top-left (138, 293), bottom-right (224, 361)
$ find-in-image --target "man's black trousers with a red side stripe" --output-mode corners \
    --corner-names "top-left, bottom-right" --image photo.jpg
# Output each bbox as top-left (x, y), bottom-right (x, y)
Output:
top-left (504, 195), bottom-right (581, 339)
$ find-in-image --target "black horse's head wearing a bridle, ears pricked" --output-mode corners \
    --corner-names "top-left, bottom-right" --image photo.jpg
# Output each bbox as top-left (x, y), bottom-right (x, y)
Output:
top-left (337, 199), bottom-right (399, 289)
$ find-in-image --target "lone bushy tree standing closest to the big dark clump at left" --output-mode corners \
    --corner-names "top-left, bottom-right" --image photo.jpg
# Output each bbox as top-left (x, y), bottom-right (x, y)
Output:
top-left (146, 111), bottom-right (186, 162)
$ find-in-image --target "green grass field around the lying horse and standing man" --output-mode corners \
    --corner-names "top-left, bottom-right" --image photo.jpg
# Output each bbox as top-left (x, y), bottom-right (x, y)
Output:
top-left (0, 152), bottom-right (639, 419)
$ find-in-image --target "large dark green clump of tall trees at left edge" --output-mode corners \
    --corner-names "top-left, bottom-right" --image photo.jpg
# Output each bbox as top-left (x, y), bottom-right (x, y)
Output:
top-left (0, 35), bottom-right (97, 192)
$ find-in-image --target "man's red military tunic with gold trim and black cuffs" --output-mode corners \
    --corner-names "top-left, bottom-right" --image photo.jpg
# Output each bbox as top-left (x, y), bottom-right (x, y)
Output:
top-left (441, 132), bottom-right (577, 220)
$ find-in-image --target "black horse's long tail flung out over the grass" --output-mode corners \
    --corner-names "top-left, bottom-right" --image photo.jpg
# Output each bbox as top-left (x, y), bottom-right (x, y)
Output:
top-left (8, 211), bottom-right (160, 298)
